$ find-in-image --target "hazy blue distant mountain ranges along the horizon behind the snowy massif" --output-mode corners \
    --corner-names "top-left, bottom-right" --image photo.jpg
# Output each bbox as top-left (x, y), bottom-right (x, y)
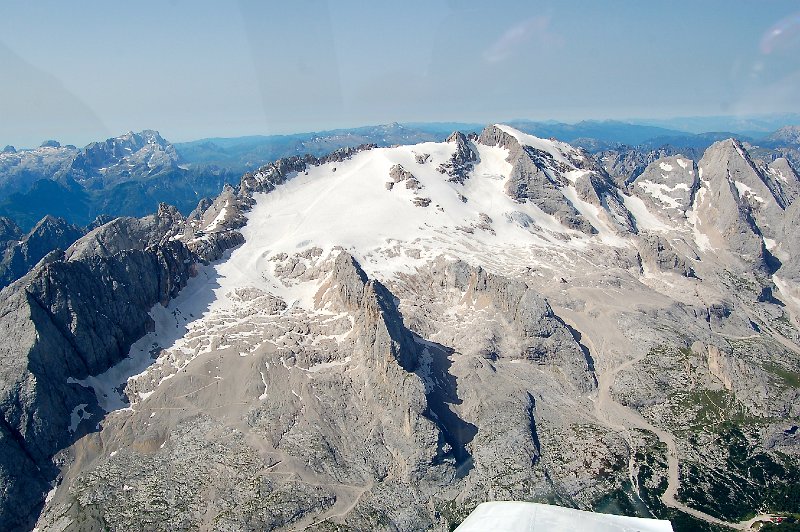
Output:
top-left (0, 119), bottom-right (800, 231)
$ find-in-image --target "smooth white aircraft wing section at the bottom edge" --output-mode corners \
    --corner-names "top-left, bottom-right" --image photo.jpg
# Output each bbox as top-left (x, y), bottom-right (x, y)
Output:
top-left (456, 501), bottom-right (672, 532)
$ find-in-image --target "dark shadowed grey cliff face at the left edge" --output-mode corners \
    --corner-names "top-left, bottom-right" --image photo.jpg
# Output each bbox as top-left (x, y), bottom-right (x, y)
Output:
top-left (0, 230), bottom-right (194, 528)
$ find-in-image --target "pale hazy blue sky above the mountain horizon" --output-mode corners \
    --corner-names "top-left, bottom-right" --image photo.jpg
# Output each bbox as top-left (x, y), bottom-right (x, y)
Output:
top-left (0, 0), bottom-right (800, 147)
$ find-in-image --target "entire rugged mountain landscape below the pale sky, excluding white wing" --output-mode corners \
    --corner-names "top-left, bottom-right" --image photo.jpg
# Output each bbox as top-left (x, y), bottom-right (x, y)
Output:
top-left (0, 124), bottom-right (800, 531)
